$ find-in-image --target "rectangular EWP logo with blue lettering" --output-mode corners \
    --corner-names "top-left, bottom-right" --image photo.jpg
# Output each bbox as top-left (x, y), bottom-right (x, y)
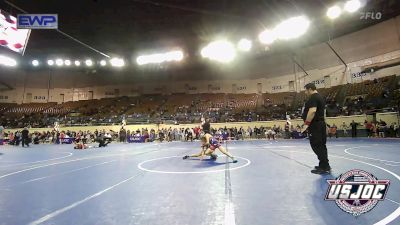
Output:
top-left (17, 14), bottom-right (58, 29)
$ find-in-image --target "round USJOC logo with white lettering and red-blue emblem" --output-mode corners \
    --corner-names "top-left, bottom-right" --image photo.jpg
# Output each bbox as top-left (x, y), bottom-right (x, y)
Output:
top-left (325, 169), bottom-right (390, 216)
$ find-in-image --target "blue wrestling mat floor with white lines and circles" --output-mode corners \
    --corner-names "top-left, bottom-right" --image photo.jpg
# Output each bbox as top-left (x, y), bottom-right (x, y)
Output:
top-left (0, 139), bottom-right (400, 225)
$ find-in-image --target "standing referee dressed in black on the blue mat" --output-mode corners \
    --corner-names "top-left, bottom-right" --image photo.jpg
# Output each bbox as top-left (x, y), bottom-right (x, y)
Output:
top-left (302, 83), bottom-right (331, 174)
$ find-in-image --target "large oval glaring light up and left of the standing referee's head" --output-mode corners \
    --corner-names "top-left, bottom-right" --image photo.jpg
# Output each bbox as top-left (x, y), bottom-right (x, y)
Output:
top-left (274, 16), bottom-right (310, 40)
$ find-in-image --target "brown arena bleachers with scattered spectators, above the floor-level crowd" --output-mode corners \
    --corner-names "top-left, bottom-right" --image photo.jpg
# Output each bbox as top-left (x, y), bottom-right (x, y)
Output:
top-left (0, 75), bottom-right (400, 128)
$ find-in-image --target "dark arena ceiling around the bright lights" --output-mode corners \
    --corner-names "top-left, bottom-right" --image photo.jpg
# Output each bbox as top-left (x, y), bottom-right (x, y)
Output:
top-left (0, 0), bottom-right (400, 82)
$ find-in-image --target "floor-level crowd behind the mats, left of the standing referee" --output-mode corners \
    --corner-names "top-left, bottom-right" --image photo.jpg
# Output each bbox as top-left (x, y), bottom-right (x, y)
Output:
top-left (0, 122), bottom-right (302, 146)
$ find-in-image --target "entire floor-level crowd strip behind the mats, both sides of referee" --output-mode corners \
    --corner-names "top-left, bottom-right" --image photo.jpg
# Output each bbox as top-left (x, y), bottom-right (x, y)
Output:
top-left (3, 117), bottom-right (400, 146)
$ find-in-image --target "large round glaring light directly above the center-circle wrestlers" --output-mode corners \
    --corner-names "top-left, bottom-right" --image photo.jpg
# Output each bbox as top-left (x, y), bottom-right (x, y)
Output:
top-left (201, 41), bottom-right (236, 63)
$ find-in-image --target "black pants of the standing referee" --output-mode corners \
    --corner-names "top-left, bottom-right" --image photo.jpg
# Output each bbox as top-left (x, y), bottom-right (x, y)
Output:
top-left (308, 121), bottom-right (330, 169)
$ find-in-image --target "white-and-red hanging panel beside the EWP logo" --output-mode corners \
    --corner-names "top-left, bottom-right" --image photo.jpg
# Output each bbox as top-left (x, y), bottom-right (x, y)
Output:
top-left (0, 10), bottom-right (30, 54)
